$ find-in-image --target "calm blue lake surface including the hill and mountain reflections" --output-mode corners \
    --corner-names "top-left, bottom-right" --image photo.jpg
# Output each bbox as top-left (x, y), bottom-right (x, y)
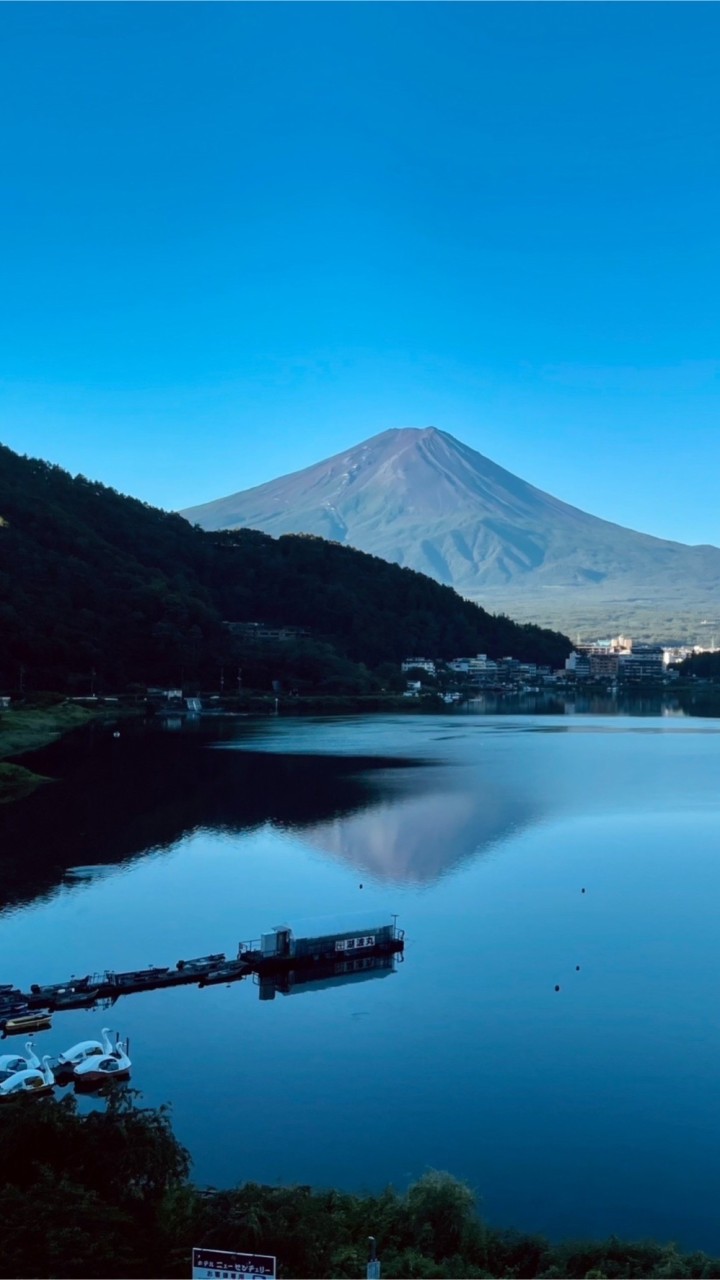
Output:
top-left (0, 714), bottom-right (720, 1252)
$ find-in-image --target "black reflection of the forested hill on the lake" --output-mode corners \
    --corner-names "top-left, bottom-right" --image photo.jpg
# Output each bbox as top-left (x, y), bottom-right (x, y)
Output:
top-left (0, 723), bottom-right (427, 908)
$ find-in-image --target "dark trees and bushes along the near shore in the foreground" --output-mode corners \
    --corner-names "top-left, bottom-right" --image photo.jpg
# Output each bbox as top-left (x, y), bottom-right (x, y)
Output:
top-left (0, 1088), bottom-right (720, 1280)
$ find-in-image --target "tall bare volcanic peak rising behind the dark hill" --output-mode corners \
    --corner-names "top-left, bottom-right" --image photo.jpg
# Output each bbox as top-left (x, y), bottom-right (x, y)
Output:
top-left (181, 426), bottom-right (720, 639)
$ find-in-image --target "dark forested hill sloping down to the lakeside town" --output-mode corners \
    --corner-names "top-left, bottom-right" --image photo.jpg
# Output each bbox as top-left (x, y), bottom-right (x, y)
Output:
top-left (0, 445), bottom-right (570, 691)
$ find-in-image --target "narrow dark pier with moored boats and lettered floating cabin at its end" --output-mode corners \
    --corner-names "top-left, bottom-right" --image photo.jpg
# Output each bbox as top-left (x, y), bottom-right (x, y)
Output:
top-left (0, 920), bottom-right (405, 1030)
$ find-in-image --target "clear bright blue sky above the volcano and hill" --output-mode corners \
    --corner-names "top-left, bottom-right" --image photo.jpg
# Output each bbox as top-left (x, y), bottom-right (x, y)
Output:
top-left (0, 3), bottom-right (720, 544)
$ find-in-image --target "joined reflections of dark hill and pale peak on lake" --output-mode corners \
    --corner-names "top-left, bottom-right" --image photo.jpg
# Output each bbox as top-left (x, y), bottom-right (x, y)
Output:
top-left (0, 723), bottom-right (536, 908)
